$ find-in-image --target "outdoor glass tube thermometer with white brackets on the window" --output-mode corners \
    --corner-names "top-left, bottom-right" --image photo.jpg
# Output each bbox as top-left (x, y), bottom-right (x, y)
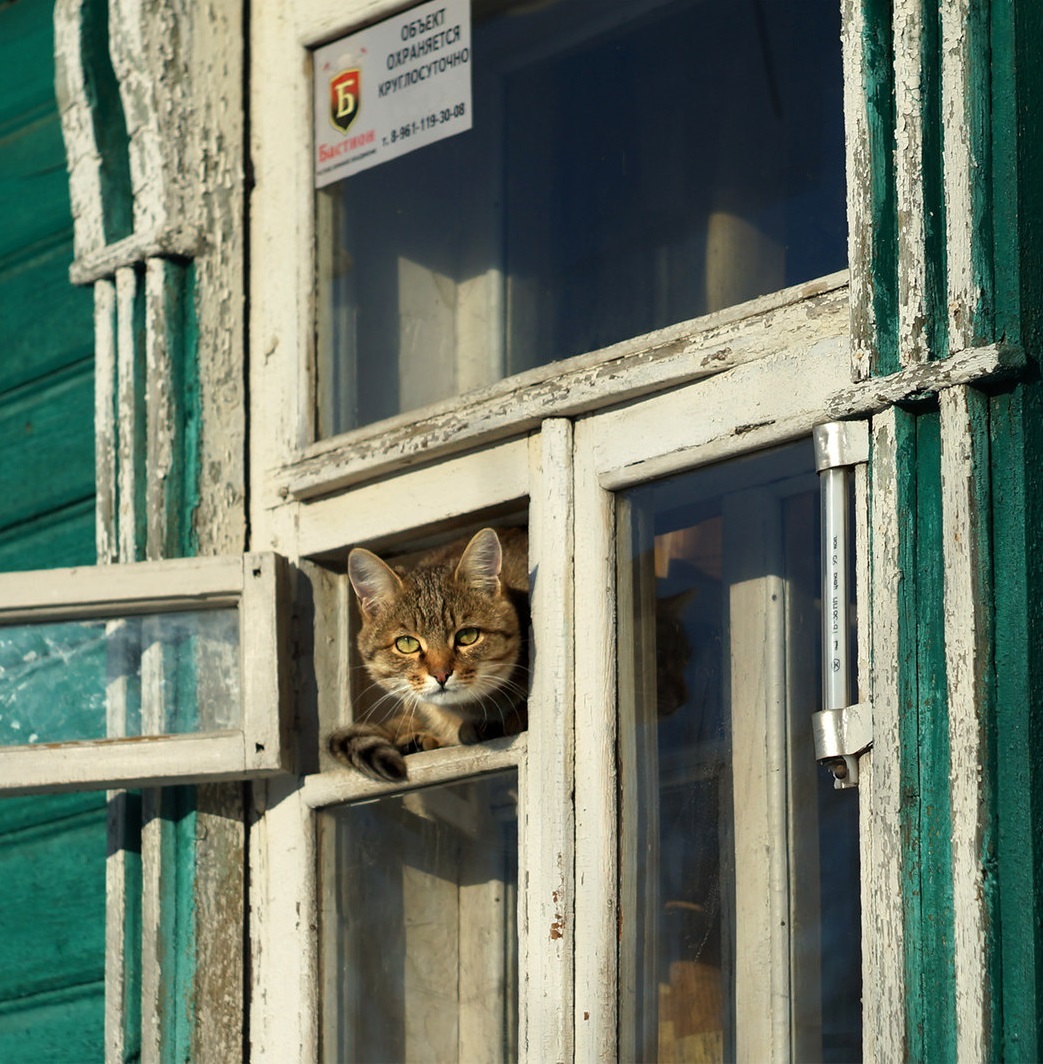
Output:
top-left (812, 421), bottom-right (873, 789)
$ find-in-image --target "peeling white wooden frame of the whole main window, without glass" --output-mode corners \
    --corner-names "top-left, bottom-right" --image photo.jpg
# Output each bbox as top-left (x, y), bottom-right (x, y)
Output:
top-left (250, 0), bottom-right (1019, 1061)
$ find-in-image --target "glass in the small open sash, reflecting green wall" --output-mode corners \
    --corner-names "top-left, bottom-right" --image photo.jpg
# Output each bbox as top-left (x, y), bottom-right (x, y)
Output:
top-left (0, 609), bottom-right (242, 746)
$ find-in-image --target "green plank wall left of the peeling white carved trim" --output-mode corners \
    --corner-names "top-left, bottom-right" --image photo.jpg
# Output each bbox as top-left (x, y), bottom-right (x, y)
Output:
top-left (0, 0), bottom-right (106, 1064)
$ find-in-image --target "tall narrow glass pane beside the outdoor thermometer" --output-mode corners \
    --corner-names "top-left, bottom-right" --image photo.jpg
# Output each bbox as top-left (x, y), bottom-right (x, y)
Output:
top-left (618, 444), bottom-right (861, 1062)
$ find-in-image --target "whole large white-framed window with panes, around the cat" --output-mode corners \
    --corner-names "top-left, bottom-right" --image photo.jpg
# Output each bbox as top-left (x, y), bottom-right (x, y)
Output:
top-left (251, 0), bottom-right (868, 1060)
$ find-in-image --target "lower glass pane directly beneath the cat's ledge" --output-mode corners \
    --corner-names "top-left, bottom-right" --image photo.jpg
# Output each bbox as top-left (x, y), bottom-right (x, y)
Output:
top-left (319, 771), bottom-right (518, 1062)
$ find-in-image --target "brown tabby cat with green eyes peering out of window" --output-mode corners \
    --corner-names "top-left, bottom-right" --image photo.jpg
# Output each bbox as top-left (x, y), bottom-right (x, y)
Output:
top-left (328, 529), bottom-right (529, 781)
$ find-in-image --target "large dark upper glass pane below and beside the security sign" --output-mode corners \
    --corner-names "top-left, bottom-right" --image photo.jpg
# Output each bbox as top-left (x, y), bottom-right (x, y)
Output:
top-left (318, 0), bottom-right (847, 435)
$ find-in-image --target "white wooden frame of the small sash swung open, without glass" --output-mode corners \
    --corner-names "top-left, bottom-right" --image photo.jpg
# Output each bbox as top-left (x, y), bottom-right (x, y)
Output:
top-left (0, 553), bottom-right (291, 795)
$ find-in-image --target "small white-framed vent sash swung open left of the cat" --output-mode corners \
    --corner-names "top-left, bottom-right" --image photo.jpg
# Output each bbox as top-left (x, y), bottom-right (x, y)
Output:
top-left (0, 554), bottom-right (289, 792)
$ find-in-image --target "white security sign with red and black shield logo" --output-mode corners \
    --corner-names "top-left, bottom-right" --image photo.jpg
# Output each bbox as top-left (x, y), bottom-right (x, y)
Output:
top-left (314, 0), bottom-right (471, 188)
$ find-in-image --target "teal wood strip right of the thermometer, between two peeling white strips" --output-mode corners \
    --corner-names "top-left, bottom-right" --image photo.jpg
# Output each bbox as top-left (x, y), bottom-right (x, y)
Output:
top-left (896, 411), bottom-right (956, 1061)
